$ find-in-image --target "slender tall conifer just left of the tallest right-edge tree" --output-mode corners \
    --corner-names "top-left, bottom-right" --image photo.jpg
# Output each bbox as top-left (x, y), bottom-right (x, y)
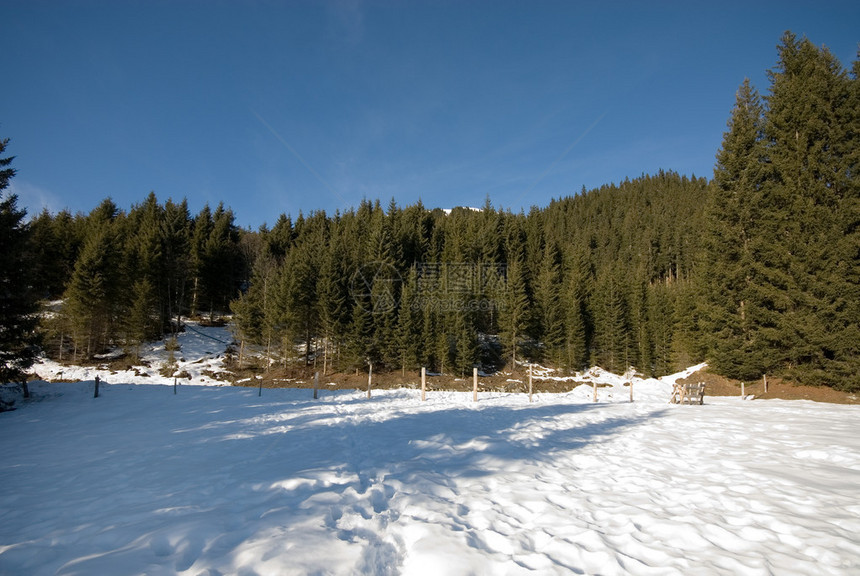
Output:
top-left (700, 80), bottom-right (768, 379)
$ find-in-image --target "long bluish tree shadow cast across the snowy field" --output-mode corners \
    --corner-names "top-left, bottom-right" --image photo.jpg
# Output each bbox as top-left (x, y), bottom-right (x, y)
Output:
top-left (0, 389), bottom-right (663, 574)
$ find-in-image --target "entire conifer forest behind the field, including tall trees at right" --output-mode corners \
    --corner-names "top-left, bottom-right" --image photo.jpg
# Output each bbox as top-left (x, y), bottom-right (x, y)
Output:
top-left (0, 33), bottom-right (860, 390)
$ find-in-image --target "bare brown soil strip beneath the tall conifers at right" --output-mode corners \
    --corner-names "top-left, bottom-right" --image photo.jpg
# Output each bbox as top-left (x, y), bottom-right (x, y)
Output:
top-left (679, 368), bottom-right (860, 404)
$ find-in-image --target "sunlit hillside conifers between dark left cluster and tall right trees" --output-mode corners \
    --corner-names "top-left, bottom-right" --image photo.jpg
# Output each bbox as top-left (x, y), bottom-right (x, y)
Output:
top-left (232, 172), bottom-right (708, 374)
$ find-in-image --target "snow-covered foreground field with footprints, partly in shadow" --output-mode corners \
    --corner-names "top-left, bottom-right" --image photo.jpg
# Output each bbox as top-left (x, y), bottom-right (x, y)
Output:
top-left (0, 326), bottom-right (860, 576)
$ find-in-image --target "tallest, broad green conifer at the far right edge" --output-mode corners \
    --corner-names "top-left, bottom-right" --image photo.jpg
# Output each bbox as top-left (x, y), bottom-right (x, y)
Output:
top-left (765, 33), bottom-right (858, 385)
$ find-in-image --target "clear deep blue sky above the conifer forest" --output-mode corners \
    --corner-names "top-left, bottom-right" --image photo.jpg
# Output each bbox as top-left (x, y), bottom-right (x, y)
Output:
top-left (0, 0), bottom-right (860, 229)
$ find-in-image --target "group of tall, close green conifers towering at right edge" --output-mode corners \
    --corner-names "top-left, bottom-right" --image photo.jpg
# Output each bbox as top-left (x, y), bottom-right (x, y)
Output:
top-left (701, 33), bottom-right (860, 389)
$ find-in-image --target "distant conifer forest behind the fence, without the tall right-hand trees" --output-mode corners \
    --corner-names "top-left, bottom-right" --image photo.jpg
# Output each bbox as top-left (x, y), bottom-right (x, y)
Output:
top-left (30, 173), bottom-right (707, 374)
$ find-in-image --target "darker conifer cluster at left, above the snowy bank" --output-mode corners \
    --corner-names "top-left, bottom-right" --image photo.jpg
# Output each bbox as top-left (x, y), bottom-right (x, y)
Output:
top-left (29, 193), bottom-right (247, 360)
